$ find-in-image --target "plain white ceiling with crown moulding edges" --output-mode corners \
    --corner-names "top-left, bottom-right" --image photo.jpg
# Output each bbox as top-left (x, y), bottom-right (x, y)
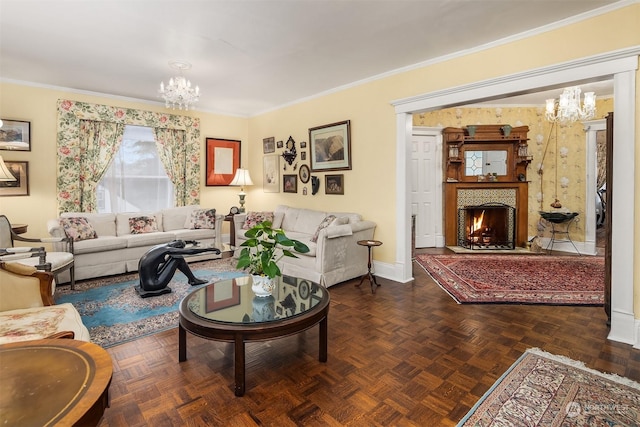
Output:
top-left (0, 0), bottom-right (620, 116)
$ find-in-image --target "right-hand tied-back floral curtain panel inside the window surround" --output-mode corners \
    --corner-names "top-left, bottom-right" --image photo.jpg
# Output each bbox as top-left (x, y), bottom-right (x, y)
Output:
top-left (153, 128), bottom-right (189, 206)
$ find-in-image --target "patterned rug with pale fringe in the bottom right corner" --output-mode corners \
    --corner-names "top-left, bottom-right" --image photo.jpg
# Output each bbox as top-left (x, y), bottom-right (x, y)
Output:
top-left (458, 349), bottom-right (640, 426)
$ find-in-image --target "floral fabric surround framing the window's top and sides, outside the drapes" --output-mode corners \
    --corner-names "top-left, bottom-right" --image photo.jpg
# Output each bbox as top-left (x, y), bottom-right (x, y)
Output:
top-left (56, 99), bottom-right (200, 212)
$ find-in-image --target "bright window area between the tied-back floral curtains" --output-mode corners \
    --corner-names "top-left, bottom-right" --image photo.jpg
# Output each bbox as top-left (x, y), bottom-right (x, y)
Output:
top-left (96, 125), bottom-right (174, 213)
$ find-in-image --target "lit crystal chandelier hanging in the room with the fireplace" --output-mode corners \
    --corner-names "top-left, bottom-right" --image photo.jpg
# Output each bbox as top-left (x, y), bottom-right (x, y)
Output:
top-left (545, 86), bottom-right (596, 124)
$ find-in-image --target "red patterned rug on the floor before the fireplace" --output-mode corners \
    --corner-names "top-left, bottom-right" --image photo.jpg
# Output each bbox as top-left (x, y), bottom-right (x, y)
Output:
top-left (416, 254), bottom-right (604, 305)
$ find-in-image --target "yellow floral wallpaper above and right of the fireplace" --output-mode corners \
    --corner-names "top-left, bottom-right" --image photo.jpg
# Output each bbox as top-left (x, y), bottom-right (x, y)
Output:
top-left (413, 98), bottom-right (613, 241)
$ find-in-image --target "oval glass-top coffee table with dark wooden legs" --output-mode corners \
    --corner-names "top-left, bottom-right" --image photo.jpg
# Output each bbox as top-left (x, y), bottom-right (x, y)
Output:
top-left (178, 276), bottom-right (330, 396)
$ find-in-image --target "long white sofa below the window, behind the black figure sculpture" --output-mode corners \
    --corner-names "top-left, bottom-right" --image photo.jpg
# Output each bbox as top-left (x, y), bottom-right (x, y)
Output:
top-left (47, 205), bottom-right (224, 283)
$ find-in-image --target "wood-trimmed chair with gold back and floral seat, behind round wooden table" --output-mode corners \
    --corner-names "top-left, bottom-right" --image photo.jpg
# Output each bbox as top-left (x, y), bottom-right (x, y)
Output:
top-left (0, 262), bottom-right (90, 344)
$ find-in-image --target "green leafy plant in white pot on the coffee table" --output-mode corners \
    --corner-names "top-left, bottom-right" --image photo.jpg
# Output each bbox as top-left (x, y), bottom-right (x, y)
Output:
top-left (236, 221), bottom-right (309, 296)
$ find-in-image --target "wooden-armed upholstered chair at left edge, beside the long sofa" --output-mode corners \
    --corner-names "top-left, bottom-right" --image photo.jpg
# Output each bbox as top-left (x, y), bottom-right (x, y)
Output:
top-left (0, 215), bottom-right (75, 289)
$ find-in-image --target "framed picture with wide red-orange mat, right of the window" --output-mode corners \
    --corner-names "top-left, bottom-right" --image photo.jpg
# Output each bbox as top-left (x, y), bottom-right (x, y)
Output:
top-left (205, 138), bottom-right (240, 187)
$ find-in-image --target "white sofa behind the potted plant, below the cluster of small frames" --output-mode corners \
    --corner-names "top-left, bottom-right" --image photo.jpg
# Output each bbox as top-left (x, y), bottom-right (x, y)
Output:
top-left (233, 205), bottom-right (376, 287)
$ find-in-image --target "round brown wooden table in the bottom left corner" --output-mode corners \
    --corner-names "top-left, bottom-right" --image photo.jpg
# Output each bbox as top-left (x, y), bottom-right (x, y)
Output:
top-left (0, 339), bottom-right (113, 426)
